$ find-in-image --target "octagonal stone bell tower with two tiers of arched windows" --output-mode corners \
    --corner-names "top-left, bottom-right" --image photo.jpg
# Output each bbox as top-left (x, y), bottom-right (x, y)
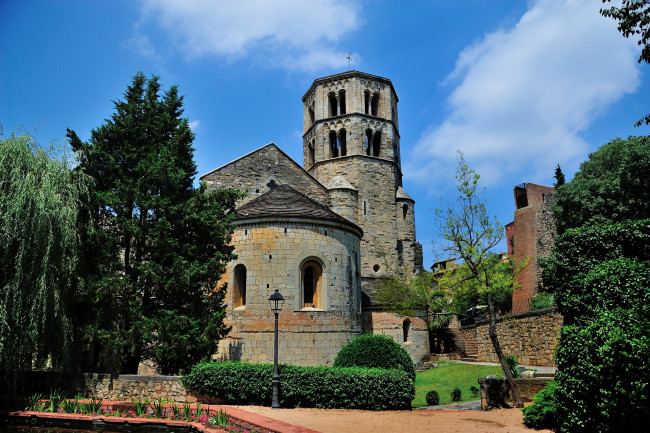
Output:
top-left (302, 71), bottom-right (422, 291)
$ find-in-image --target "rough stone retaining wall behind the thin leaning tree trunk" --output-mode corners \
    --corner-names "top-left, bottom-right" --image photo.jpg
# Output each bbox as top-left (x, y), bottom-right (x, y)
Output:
top-left (459, 308), bottom-right (563, 367)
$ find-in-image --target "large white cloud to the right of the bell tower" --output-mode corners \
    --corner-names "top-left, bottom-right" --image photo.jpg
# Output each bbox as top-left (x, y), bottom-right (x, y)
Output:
top-left (404, 0), bottom-right (640, 191)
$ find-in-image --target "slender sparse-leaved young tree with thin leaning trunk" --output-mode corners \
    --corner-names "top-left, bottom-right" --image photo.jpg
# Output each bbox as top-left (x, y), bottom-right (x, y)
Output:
top-left (435, 151), bottom-right (523, 407)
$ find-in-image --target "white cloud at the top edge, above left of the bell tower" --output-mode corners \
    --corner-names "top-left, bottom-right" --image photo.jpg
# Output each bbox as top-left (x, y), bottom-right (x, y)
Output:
top-left (137, 0), bottom-right (360, 71)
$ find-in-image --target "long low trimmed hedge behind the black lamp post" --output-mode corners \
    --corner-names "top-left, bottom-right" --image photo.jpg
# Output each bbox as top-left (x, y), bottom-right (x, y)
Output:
top-left (182, 362), bottom-right (415, 410)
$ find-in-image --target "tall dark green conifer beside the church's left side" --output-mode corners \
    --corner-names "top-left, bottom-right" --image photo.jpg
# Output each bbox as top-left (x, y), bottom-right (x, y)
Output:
top-left (68, 73), bottom-right (240, 374)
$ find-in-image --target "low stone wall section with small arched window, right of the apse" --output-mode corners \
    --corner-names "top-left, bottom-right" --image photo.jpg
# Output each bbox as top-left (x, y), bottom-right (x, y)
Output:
top-left (363, 311), bottom-right (431, 366)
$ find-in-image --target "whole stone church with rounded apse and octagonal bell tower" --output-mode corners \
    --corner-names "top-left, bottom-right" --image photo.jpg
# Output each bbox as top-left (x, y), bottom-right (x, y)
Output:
top-left (201, 71), bottom-right (430, 365)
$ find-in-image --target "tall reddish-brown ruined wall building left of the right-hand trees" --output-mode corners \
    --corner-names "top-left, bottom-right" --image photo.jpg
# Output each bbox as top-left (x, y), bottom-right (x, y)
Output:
top-left (506, 183), bottom-right (555, 313)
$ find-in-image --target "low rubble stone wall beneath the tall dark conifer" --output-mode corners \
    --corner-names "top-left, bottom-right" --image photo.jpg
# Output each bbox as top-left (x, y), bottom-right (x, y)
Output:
top-left (79, 373), bottom-right (201, 403)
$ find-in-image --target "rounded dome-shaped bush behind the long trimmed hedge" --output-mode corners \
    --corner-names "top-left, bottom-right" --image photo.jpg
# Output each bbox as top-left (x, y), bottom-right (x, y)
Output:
top-left (334, 334), bottom-right (415, 381)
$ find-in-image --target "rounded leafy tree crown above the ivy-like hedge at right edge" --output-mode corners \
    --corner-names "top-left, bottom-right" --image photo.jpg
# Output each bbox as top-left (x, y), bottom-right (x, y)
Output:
top-left (553, 137), bottom-right (650, 233)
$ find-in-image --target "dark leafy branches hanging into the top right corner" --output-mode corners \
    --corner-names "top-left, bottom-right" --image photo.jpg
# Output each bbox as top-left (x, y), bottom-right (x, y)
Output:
top-left (600, 0), bottom-right (650, 126)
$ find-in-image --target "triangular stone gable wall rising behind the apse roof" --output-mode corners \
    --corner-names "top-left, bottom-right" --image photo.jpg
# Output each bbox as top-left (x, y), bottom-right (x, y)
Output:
top-left (201, 143), bottom-right (327, 205)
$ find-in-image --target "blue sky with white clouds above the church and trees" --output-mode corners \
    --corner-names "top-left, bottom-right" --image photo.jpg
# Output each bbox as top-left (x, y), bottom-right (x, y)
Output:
top-left (0, 0), bottom-right (650, 267)
